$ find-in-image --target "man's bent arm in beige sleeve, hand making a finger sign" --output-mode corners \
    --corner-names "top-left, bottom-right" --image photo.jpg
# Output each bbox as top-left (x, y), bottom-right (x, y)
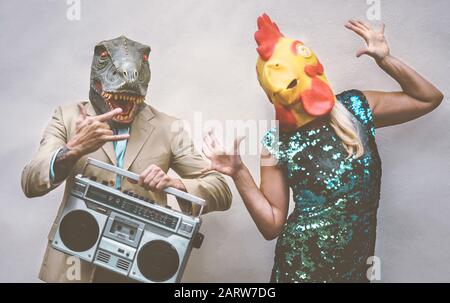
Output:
top-left (22, 104), bottom-right (129, 198)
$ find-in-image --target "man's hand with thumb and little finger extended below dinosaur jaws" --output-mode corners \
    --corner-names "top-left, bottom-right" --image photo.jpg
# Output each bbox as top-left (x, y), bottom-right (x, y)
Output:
top-left (66, 104), bottom-right (129, 158)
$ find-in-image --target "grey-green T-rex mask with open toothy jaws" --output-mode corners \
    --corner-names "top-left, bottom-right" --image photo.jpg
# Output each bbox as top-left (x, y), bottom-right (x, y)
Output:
top-left (89, 36), bottom-right (150, 128)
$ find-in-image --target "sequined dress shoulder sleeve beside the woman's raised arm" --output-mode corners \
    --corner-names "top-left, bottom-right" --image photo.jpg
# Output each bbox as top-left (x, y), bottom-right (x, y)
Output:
top-left (337, 89), bottom-right (375, 136)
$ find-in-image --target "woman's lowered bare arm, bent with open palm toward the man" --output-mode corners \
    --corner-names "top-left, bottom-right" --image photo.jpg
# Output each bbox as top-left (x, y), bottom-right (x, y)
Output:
top-left (203, 132), bottom-right (289, 240)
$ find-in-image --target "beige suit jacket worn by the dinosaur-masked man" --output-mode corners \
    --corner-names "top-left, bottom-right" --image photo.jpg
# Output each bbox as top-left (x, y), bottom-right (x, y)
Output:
top-left (22, 102), bottom-right (232, 282)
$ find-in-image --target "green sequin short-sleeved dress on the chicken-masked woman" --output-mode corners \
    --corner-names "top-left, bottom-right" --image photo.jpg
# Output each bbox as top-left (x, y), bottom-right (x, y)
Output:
top-left (262, 90), bottom-right (381, 282)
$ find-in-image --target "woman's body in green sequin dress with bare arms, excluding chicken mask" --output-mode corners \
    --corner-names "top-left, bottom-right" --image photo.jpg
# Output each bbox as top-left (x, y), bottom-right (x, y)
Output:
top-left (204, 19), bottom-right (443, 282)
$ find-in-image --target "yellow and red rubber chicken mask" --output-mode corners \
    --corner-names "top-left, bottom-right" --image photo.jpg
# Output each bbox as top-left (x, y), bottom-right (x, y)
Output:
top-left (255, 14), bottom-right (336, 131)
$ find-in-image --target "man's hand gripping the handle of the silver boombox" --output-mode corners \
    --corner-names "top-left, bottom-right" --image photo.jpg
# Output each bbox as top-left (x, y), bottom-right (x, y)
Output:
top-left (138, 164), bottom-right (186, 191)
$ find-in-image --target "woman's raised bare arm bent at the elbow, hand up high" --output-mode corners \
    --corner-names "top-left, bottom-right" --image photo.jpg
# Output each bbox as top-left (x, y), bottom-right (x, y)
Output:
top-left (345, 20), bottom-right (444, 127)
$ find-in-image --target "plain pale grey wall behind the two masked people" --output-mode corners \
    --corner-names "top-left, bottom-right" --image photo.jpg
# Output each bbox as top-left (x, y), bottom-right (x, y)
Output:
top-left (0, 0), bottom-right (450, 282)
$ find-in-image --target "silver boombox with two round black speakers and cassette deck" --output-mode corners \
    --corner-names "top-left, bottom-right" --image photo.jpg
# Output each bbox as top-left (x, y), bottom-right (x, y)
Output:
top-left (52, 159), bottom-right (205, 283)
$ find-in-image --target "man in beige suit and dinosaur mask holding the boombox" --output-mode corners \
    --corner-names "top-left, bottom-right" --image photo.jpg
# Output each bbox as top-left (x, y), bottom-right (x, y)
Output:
top-left (22, 36), bottom-right (231, 282)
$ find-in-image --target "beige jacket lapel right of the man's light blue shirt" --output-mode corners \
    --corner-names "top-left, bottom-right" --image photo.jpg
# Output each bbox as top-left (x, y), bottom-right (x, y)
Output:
top-left (123, 106), bottom-right (155, 170)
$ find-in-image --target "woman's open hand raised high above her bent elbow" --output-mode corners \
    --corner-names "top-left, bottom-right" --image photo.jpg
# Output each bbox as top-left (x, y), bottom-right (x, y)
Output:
top-left (345, 20), bottom-right (390, 62)
